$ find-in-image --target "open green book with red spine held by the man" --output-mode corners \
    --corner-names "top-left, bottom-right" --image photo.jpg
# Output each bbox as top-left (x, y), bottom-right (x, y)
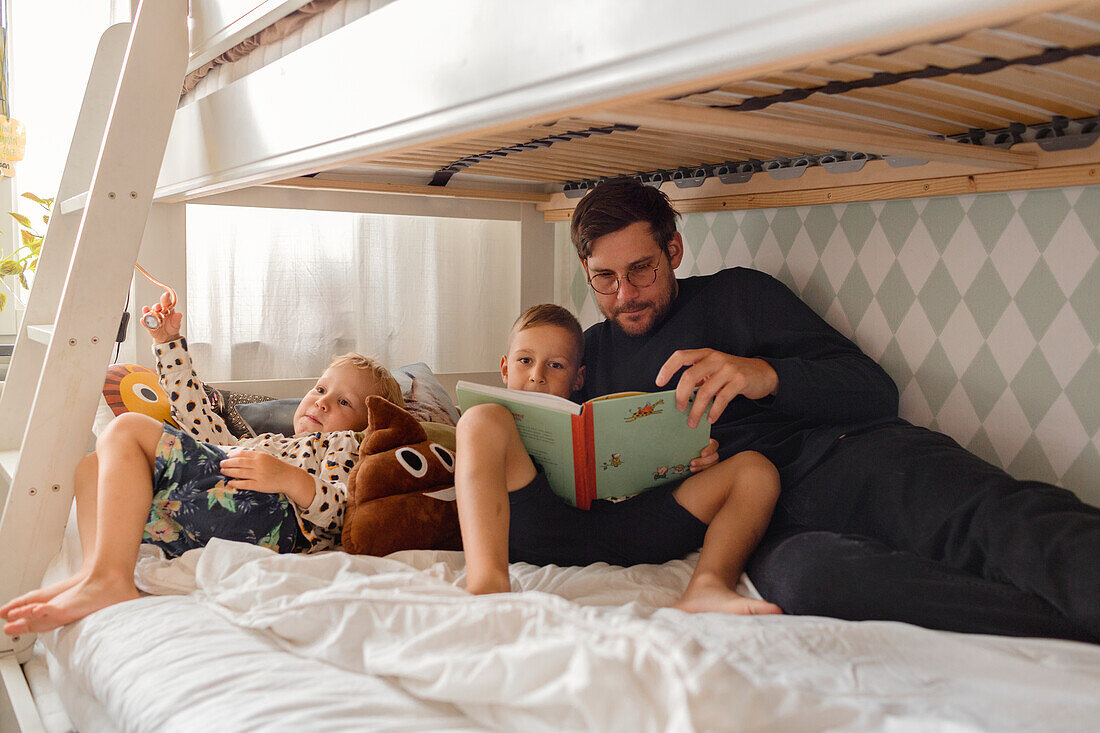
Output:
top-left (455, 382), bottom-right (711, 508)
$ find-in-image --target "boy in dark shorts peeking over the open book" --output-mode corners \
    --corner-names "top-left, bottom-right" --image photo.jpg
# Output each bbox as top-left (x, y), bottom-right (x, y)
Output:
top-left (454, 305), bottom-right (781, 614)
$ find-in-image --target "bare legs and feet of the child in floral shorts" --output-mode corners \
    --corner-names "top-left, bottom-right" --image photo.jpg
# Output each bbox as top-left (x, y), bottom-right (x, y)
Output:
top-left (3, 413), bottom-right (163, 636)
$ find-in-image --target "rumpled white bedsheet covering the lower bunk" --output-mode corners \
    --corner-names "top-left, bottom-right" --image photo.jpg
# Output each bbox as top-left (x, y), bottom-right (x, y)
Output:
top-left (43, 541), bottom-right (1100, 733)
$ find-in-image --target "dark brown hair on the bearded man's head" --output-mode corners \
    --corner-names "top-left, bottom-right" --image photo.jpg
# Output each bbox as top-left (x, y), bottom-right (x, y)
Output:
top-left (569, 178), bottom-right (680, 260)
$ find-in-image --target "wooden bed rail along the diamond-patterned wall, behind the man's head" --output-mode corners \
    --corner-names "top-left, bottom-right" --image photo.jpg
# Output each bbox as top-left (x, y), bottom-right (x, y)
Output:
top-left (543, 163), bottom-right (1100, 221)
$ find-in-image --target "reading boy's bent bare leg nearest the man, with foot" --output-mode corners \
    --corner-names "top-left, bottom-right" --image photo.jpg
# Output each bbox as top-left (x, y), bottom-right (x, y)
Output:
top-left (673, 451), bottom-right (782, 615)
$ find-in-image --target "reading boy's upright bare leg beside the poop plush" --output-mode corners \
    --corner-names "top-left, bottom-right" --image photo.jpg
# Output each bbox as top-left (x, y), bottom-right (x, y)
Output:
top-left (454, 404), bottom-right (536, 595)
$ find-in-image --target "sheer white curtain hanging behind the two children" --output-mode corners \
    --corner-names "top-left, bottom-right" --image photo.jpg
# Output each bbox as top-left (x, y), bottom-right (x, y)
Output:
top-left (184, 205), bottom-right (519, 381)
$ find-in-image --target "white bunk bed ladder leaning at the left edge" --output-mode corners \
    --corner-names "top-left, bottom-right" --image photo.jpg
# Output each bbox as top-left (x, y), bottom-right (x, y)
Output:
top-left (0, 0), bottom-right (188, 730)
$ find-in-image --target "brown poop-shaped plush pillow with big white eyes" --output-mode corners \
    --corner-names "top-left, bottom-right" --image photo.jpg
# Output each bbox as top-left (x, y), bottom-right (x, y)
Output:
top-left (341, 395), bottom-right (462, 555)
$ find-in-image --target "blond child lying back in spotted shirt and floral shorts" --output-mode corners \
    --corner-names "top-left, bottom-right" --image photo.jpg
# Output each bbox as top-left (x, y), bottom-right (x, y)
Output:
top-left (0, 298), bottom-right (404, 635)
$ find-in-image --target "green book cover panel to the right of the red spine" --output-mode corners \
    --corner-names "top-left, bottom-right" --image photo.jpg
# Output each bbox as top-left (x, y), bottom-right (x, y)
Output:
top-left (586, 390), bottom-right (711, 499)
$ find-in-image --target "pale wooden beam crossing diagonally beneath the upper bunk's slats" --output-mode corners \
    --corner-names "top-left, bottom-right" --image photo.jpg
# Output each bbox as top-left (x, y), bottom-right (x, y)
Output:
top-left (584, 101), bottom-right (1036, 171)
